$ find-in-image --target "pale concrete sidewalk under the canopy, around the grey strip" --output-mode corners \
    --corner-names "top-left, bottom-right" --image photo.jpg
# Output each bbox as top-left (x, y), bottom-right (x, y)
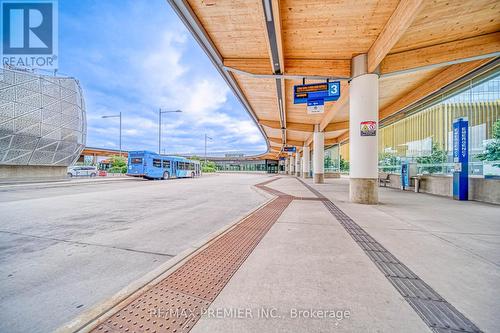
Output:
top-left (191, 177), bottom-right (500, 332)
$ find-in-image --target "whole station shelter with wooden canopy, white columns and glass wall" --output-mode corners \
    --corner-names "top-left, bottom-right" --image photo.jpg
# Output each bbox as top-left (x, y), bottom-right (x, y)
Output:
top-left (169, 0), bottom-right (500, 204)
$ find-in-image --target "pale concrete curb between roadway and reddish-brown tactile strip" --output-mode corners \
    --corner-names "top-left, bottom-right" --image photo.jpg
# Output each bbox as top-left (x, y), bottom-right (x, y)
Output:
top-left (54, 185), bottom-right (277, 333)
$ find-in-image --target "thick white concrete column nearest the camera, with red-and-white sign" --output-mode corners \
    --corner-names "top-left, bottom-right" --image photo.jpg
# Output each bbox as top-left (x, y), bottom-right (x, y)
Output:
top-left (349, 54), bottom-right (379, 204)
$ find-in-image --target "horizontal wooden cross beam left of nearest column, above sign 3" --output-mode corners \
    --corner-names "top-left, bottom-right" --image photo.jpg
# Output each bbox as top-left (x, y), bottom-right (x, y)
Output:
top-left (223, 58), bottom-right (351, 78)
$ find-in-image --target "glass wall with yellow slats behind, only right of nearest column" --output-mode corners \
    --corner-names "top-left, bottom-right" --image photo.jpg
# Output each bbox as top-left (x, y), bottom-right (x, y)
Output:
top-left (379, 68), bottom-right (500, 175)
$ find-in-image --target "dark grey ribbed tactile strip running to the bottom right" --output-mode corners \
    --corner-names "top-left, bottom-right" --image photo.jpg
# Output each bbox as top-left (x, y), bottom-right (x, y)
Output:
top-left (298, 179), bottom-right (482, 333)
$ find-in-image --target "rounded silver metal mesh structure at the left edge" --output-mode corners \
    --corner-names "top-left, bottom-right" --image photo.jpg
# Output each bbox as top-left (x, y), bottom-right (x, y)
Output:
top-left (0, 69), bottom-right (87, 166)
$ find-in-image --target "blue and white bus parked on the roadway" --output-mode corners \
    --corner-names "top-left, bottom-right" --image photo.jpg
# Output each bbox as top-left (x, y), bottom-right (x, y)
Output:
top-left (127, 151), bottom-right (201, 179)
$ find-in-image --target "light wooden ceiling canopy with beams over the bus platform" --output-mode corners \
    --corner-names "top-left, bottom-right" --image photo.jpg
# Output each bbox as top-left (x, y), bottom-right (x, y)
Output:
top-left (181, 0), bottom-right (500, 156)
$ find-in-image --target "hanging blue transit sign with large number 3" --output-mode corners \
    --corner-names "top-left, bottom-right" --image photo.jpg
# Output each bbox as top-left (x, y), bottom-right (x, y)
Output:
top-left (293, 81), bottom-right (340, 104)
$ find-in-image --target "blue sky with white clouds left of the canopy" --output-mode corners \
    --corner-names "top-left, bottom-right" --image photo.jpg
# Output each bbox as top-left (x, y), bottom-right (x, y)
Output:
top-left (59, 0), bottom-right (266, 153)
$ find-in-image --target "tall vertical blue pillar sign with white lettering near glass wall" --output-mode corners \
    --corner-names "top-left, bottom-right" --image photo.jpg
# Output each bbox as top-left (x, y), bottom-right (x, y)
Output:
top-left (453, 118), bottom-right (469, 200)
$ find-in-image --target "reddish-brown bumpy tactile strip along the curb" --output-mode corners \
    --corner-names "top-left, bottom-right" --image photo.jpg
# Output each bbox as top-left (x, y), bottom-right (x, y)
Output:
top-left (92, 178), bottom-right (294, 333)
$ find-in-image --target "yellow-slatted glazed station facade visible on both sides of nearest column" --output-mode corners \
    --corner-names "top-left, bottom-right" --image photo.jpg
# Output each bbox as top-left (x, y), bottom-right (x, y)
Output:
top-left (325, 67), bottom-right (500, 176)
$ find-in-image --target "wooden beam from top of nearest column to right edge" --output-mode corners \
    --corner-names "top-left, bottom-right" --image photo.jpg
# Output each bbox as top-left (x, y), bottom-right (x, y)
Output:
top-left (380, 32), bottom-right (500, 74)
